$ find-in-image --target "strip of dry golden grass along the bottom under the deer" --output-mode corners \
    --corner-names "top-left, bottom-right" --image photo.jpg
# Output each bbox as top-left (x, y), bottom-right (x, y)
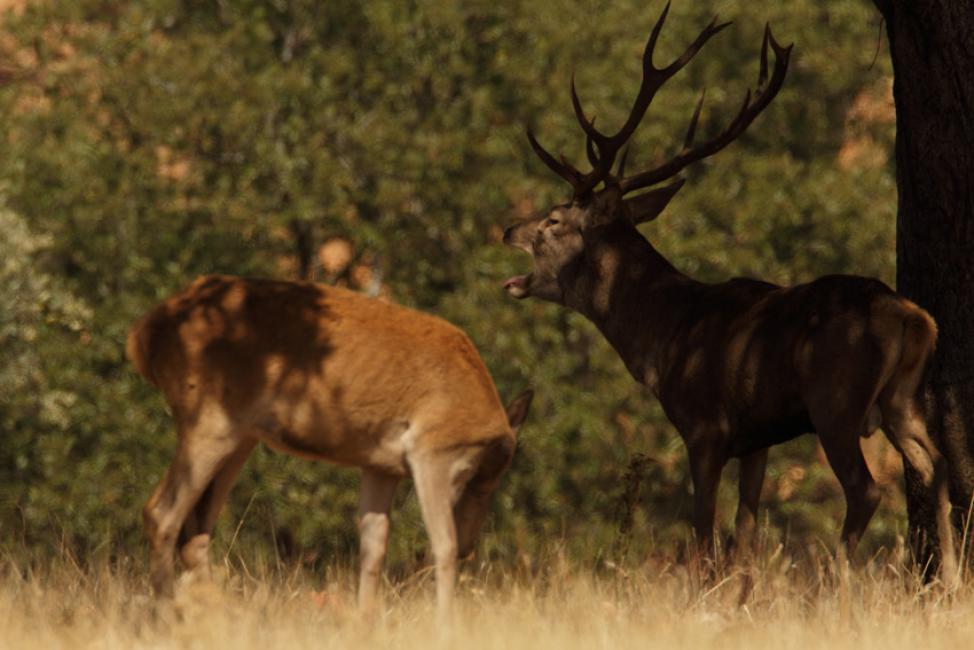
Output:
top-left (0, 550), bottom-right (974, 650)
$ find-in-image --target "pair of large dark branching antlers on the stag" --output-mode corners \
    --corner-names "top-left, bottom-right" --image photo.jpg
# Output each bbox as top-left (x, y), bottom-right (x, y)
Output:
top-left (527, 2), bottom-right (792, 199)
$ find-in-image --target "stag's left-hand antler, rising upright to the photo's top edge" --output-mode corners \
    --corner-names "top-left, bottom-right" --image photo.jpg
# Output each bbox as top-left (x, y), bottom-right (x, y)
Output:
top-left (571, 2), bottom-right (730, 197)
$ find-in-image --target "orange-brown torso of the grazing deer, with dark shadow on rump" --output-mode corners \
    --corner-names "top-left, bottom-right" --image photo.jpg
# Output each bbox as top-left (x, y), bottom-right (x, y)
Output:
top-left (128, 276), bottom-right (510, 464)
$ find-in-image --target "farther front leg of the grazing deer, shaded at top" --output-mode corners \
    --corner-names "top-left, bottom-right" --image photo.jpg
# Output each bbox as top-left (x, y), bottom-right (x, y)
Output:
top-left (358, 469), bottom-right (399, 611)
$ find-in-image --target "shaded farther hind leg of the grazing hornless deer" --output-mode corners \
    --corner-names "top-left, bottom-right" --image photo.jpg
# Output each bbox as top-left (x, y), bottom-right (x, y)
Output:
top-left (178, 440), bottom-right (257, 580)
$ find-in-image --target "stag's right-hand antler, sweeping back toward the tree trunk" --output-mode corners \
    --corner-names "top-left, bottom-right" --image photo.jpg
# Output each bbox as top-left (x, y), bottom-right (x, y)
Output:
top-left (619, 26), bottom-right (793, 194)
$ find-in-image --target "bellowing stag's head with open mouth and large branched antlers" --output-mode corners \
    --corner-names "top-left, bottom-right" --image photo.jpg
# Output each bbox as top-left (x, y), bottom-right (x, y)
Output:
top-left (504, 4), bottom-right (791, 304)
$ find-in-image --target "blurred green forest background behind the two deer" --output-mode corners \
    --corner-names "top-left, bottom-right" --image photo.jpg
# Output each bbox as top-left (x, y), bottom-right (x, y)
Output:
top-left (0, 0), bottom-right (906, 567)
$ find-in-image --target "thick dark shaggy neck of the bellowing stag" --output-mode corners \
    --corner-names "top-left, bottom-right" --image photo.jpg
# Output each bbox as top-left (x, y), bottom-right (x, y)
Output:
top-left (565, 224), bottom-right (695, 391)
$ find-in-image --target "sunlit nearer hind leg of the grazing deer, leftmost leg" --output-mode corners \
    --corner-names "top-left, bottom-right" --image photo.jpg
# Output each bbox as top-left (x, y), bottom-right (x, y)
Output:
top-left (142, 418), bottom-right (240, 596)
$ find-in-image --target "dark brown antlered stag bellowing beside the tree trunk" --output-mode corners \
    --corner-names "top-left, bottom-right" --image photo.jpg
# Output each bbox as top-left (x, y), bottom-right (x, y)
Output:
top-left (504, 5), bottom-right (956, 581)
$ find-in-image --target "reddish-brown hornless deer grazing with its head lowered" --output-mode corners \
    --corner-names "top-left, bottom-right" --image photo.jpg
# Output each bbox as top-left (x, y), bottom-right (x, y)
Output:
top-left (127, 276), bottom-right (532, 616)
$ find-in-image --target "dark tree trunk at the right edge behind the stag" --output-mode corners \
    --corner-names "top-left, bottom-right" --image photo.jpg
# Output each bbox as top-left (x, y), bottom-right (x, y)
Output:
top-left (876, 0), bottom-right (974, 561)
